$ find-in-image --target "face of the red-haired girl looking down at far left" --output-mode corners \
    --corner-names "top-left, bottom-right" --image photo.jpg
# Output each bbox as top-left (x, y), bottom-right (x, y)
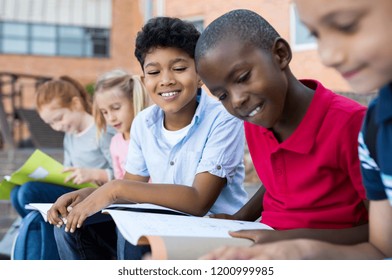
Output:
top-left (39, 98), bottom-right (88, 134)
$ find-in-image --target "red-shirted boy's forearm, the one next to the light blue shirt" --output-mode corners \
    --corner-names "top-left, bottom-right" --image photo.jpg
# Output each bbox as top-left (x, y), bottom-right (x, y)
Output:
top-left (210, 185), bottom-right (265, 222)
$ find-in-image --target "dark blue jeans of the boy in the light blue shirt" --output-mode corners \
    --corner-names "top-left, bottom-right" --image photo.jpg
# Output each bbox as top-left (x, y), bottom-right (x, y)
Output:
top-left (54, 218), bottom-right (150, 260)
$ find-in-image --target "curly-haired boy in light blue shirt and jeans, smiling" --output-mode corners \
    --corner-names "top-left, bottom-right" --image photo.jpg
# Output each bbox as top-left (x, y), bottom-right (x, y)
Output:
top-left (48, 17), bottom-right (247, 259)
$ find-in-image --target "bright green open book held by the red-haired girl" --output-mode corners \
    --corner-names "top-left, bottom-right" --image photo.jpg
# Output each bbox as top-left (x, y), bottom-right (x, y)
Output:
top-left (0, 149), bottom-right (96, 200)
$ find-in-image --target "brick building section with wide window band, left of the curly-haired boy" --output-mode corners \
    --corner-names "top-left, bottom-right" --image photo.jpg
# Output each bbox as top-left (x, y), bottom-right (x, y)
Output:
top-left (0, 0), bottom-right (143, 83)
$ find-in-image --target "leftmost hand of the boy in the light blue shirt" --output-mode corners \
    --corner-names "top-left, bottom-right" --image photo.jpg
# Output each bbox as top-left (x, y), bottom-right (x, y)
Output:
top-left (47, 188), bottom-right (94, 227)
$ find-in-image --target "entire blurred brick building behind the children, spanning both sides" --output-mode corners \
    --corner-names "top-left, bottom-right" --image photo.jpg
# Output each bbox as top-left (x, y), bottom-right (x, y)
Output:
top-left (0, 0), bottom-right (356, 91)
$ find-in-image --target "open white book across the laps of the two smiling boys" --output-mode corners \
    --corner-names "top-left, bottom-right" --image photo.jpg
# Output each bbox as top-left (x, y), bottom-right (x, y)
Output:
top-left (29, 203), bottom-right (272, 260)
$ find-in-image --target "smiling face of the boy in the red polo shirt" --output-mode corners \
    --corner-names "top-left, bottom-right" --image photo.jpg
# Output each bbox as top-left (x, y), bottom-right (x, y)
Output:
top-left (198, 38), bottom-right (287, 128)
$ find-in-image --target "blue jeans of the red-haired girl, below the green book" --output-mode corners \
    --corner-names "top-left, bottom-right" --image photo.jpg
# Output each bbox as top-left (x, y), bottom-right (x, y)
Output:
top-left (11, 182), bottom-right (75, 218)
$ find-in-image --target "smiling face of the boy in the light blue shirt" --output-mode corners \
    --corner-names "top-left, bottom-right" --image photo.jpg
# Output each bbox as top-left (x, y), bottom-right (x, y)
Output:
top-left (143, 47), bottom-right (200, 119)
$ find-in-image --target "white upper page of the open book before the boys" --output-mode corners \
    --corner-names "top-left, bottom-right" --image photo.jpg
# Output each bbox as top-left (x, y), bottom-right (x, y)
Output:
top-left (103, 209), bottom-right (272, 245)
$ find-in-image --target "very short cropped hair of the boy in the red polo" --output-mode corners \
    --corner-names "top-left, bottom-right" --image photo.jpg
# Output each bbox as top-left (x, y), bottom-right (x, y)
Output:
top-left (195, 9), bottom-right (280, 61)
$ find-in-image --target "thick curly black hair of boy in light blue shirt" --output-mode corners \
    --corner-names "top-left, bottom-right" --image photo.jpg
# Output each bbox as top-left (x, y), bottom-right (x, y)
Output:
top-left (135, 17), bottom-right (200, 69)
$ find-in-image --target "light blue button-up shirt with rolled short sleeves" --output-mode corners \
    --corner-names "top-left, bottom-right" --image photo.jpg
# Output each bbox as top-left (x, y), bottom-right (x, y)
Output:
top-left (125, 91), bottom-right (247, 214)
